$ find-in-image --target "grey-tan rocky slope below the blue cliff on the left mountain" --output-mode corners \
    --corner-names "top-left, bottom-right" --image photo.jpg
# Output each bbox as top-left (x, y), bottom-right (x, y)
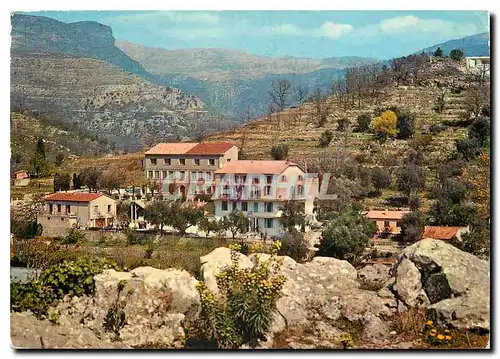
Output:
top-left (11, 52), bottom-right (230, 150)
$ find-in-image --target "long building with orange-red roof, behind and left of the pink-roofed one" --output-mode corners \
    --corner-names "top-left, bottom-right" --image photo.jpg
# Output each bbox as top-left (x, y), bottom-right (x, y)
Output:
top-left (144, 142), bottom-right (238, 199)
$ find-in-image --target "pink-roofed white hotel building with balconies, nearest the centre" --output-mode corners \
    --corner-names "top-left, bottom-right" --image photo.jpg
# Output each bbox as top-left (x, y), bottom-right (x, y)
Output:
top-left (212, 160), bottom-right (319, 236)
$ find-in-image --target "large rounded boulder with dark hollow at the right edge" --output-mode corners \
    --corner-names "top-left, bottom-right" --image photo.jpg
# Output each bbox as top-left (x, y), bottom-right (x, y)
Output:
top-left (394, 239), bottom-right (490, 330)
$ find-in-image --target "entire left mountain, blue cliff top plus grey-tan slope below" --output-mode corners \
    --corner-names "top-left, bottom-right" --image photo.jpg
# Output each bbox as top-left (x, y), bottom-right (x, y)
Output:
top-left (11, 15), bottom-right (229, 150)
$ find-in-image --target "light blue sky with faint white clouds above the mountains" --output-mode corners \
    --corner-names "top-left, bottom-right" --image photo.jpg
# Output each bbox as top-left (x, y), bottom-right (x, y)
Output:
top-left (19, 11), bottom-right (489, 59)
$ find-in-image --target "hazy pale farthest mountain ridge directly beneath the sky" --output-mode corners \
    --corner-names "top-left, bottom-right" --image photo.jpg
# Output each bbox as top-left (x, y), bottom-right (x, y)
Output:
top-left (116, 41), bottom-right (376, 81)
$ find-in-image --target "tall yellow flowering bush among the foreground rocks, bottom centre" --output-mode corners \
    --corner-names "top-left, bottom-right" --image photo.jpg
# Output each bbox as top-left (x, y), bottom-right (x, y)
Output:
top-left (197, 244), bottom-right (285, 349)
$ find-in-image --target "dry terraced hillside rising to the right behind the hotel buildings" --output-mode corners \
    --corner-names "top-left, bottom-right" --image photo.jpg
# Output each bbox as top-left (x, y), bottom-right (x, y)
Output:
top-left (206, 60), bottom-right (489, 208)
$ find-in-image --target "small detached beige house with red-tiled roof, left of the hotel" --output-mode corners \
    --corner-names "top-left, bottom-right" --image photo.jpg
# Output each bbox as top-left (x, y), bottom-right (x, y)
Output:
top-left (37, 192), bottom-right (116, 234)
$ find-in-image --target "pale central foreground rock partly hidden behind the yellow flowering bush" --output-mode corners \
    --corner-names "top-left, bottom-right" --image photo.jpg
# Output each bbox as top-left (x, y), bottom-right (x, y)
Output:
top-left (202, 248), bottom-right (394, 348)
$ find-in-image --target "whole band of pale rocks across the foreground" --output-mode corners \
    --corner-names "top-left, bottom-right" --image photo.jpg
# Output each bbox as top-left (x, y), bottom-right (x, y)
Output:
top-left (11, 239), bottom-right (490, 349)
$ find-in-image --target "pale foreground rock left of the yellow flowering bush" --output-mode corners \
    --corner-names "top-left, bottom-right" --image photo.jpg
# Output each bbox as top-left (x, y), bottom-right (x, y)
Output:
top-left (12, 267), bottom-right (200, 348)
